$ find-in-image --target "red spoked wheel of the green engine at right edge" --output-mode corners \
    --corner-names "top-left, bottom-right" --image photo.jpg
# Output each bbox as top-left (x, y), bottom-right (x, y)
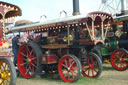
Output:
top-left (111, 49), bottom-right (128, 71)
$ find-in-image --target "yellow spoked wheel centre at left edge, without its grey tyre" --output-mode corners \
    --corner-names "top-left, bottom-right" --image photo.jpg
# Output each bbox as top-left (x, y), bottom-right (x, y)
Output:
top-left (0, 61), bottom-right (11, 85)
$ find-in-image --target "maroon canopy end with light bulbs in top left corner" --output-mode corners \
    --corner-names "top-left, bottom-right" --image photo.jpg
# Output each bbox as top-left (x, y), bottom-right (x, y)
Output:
top-left (0, 1), bottom-right (21, 19)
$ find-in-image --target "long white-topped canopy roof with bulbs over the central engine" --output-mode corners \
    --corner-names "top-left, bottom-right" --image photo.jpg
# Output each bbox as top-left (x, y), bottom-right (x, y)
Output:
top-left (9, 11), bottom-right (113, 32)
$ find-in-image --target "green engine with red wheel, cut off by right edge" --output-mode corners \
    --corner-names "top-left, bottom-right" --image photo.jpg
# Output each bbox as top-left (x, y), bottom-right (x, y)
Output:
top-left (97, 15), bottom-right (128, 71)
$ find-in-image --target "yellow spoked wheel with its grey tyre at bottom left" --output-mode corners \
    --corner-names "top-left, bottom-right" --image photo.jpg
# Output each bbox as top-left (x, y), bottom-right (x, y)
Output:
top-left (0, 58), bottom-right (16, 85)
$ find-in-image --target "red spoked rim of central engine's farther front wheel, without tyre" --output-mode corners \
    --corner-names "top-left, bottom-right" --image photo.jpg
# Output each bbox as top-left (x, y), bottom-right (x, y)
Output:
top-left (82, 54), bottom-right (100, 78)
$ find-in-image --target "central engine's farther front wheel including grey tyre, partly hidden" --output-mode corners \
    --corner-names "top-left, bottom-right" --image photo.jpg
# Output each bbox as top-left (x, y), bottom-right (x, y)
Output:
top-left (82, 52), bottom-right (102, 78)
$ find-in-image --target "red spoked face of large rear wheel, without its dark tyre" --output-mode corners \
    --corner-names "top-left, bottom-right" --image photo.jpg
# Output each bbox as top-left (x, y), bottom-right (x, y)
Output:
top-left (17, 44), bottom-right (37, 78)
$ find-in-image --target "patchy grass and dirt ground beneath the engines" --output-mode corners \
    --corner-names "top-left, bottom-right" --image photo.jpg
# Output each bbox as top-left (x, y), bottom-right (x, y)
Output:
top-left (16, 65), bottom-right (128, 85)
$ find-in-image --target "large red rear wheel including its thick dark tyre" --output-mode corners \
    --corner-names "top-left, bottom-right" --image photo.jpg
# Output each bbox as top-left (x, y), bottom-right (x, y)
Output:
top-left (17, 43), bottom-right (41, 78)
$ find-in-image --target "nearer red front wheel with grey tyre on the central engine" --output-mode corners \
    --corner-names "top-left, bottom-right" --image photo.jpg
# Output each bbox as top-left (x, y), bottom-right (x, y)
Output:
top-left (58, 55), bottom-right (81, 82)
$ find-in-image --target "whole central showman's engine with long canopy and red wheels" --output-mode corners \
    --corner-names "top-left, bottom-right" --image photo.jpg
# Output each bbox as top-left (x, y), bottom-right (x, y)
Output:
top-left (9, 12), bottom-right (113, 82)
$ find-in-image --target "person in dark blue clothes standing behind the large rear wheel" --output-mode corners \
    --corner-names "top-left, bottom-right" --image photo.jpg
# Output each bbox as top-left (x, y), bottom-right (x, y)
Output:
top-left (12, 35), bottom-right (21, 66)
